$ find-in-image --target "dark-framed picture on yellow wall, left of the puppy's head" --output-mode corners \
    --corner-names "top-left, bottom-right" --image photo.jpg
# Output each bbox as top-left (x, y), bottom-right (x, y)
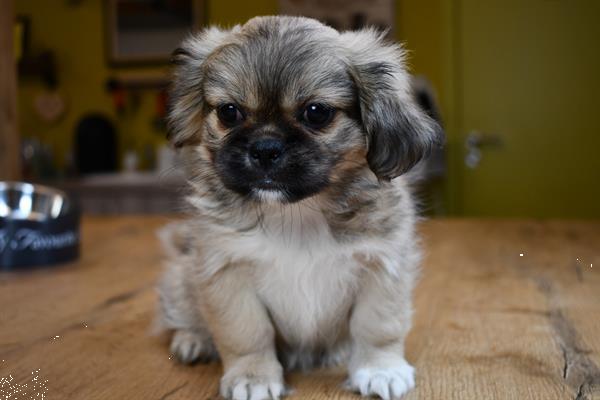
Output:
top-left (105, 0), bottom-right (205, 65)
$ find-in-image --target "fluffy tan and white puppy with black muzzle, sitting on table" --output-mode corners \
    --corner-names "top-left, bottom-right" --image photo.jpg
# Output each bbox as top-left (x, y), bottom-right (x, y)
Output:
top-left (159, 17), bottom-right (438, 400)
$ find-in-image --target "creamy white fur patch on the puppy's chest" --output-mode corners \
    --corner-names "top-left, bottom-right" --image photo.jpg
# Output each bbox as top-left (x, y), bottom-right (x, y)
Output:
top-left (229, 205), bottom-right (360, 348)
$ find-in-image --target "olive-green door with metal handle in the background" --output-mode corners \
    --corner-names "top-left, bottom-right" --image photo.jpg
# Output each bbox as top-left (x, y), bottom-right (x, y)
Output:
top-left (451, 0), bottom-right (600, 218)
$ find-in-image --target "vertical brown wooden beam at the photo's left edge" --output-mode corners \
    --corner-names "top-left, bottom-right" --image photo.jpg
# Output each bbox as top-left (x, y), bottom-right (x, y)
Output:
top-left (0, 0), bottom-right (21, 180)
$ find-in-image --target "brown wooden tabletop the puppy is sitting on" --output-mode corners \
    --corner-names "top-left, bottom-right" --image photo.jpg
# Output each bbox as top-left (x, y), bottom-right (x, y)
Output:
top-left (0, 217), bottom-right (600, 400)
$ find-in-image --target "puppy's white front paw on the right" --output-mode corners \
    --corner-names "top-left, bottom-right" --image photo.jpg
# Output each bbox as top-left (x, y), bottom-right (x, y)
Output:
top-left (348, 361), bottom-right (415, 400)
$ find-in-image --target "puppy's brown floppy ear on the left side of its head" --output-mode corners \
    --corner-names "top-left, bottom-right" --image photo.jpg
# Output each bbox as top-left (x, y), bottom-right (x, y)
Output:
top-left (167, 26), bottom-right (239, 148)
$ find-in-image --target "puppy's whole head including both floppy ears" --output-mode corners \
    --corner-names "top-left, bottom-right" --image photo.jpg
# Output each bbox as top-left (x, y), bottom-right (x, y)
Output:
top-left (171, 17), bottom-right (434, 202)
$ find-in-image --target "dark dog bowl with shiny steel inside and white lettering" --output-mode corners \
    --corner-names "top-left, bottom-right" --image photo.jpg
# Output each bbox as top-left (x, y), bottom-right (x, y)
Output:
top-left (0, 182), bottom-right (80, 270)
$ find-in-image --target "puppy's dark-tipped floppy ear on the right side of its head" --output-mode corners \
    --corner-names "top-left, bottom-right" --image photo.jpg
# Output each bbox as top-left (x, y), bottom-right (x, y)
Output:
top-left (340, 29), bottom-right (442, 180)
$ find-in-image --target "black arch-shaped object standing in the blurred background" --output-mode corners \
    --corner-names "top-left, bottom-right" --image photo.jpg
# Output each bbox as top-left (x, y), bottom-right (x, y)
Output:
top-left (75, 114), bottom-right (117, 174)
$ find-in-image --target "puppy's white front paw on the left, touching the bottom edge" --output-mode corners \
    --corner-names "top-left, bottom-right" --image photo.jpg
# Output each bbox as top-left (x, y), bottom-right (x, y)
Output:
top-left (221, 377), bottom-right (286, 400)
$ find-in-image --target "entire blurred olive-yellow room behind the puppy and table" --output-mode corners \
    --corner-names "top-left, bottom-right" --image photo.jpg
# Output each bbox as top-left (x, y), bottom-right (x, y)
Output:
top-left (0, 0), bottom-right (600, 218)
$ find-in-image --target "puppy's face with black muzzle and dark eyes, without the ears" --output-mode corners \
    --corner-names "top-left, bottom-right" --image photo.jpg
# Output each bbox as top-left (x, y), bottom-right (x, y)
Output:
top-left (203, 29), bottom-right (366, 202)
